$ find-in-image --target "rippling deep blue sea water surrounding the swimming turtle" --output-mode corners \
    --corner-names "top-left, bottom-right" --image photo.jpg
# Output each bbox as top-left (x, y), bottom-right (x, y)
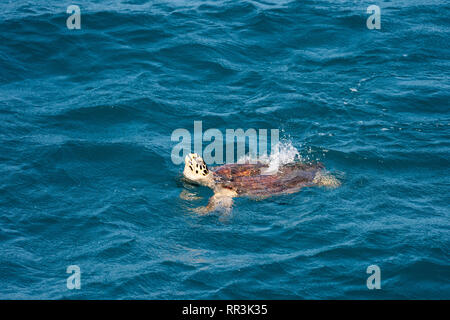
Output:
top-left (0, 0), bottom-right (450, 299)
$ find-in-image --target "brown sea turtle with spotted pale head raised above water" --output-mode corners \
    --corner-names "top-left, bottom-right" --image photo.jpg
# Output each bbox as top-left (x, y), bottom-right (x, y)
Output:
top-left (183, 153), bottom-right (339, 214)
